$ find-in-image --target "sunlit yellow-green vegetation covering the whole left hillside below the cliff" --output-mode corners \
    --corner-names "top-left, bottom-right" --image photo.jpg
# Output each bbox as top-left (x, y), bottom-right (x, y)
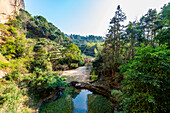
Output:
top-left (0, 10), bottom-right (84, 113)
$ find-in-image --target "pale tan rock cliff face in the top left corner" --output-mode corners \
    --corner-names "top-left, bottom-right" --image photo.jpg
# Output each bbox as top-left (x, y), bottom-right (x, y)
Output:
top-left (0, 0), bottom-right (25, 23)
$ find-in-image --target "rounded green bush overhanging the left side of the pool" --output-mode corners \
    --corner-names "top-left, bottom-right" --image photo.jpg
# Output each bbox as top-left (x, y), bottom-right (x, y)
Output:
top-left (24, 69), bottom-right (66, 98)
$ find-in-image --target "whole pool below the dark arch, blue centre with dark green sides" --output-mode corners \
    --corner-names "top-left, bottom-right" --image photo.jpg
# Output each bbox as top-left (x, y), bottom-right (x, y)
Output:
top-left (39, 87), bottom-right (113, 113)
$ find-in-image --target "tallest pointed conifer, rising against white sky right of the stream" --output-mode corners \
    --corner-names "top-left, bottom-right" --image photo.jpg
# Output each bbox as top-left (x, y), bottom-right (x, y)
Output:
top-left (93, 6), bottom-right (126, 78)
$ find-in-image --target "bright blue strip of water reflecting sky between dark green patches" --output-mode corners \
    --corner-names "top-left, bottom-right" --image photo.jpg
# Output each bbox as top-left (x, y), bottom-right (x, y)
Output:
top-left (72, 90), bottom-right (92, 113)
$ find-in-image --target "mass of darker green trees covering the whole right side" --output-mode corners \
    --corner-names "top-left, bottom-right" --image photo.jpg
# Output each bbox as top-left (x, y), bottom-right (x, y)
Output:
top-left (93, 3), bottom-right (170, 113)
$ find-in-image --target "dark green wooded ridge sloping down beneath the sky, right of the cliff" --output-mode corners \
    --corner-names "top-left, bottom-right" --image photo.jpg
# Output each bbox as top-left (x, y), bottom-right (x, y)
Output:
top-left (17, 9), bottom-right (71, 46)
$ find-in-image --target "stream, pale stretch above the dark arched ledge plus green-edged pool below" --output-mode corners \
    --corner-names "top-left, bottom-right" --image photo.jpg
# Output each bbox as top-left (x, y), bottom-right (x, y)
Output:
top-left (39, 65), bottom-right (113, 113)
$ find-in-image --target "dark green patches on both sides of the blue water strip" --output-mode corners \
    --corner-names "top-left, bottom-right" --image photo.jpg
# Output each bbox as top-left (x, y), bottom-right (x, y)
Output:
top-left (40, 87), bottom-right (113, 113)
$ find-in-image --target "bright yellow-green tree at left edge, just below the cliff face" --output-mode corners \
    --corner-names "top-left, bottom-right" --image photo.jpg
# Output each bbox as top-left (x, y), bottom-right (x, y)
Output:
top-left (0, 26), bottom-right (29, 59)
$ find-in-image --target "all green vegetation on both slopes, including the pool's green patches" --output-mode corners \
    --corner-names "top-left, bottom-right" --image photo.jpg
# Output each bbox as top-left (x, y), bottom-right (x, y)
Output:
top-left (0, 3), bottom-right (170, 113)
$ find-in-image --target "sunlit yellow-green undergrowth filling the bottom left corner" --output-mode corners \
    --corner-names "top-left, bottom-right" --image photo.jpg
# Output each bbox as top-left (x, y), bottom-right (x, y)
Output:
top-left (0, 72), bottom-right (39, 113)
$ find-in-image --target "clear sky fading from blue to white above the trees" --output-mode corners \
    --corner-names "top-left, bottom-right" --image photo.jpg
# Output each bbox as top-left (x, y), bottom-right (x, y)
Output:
top-left (24, 0), bottom-right (169, 36)
